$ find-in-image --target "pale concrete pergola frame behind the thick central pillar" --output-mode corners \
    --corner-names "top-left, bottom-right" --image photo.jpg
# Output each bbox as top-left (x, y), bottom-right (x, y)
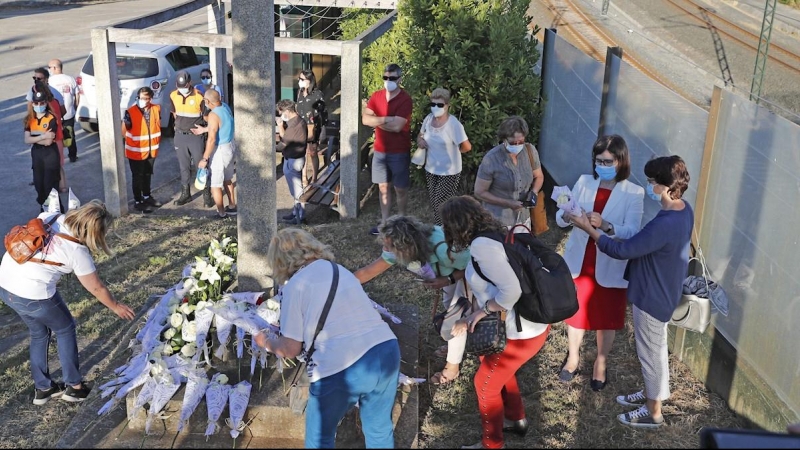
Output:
top-left (92, 0), bottom-right (397, 219)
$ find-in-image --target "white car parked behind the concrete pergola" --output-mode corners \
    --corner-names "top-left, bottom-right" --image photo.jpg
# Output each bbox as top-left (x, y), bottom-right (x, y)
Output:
top-left (76, 42), bottom-right (209, 133)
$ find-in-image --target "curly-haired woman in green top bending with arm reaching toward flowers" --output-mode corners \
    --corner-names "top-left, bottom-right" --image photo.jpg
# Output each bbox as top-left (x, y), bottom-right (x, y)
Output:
top-left (355, 216), bottom-right (469, 384)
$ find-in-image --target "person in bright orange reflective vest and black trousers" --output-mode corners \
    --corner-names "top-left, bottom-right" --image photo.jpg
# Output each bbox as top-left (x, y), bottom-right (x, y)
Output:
top-left (122, 87), bottom-right (161, 214)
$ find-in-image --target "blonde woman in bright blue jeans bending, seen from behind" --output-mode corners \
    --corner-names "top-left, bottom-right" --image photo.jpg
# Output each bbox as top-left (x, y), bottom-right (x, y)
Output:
top-left (255, 228), bottom-right (400, 448)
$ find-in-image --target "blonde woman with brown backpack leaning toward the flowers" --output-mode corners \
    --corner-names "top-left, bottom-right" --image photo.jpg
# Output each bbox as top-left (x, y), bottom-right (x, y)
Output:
top-left (0, 200), bottom-right (134, 405)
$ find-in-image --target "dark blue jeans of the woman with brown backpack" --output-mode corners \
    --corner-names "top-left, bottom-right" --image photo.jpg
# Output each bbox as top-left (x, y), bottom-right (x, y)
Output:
top-left (0, 288), bottom-right (81, 389)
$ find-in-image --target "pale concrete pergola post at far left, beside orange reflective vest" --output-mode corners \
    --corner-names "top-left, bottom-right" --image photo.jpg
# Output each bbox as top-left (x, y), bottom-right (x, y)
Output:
top-left (92, 29), bottom-right (128, 217)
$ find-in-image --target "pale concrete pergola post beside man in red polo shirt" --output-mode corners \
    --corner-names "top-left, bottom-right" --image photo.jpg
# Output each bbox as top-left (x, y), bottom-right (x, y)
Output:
top-left (338, 40), bottom-right (361, 219)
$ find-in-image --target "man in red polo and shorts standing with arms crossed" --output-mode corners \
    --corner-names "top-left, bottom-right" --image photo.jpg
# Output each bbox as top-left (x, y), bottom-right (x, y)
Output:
top-left (361, 64), bottom-right (412, 235)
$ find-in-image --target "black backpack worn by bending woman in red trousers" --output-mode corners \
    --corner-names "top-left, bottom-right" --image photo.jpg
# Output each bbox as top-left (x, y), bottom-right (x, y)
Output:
top-left (472, 225), bottom-right (578, 331)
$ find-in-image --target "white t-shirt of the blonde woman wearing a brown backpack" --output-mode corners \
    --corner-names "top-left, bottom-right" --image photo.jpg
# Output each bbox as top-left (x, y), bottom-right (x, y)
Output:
top-left (0, 213), bottom-right (97, 300)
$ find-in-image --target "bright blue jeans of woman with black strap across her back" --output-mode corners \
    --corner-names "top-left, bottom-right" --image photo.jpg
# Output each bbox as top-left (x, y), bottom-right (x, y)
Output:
top-left (305, 339), bottom-right (400, 448)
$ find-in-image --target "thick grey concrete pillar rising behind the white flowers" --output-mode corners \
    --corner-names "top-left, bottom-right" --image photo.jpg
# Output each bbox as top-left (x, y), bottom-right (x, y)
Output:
top-left (231, 0), bottom-right (278, 291)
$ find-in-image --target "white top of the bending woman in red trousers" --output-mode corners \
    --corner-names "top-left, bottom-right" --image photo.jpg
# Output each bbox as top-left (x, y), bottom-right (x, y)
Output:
top-left (465, 237), bottom-right (547, 339)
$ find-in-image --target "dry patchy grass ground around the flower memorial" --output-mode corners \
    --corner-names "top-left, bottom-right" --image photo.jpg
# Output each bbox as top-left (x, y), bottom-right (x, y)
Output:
top-left (0, 181), bottom-right (742, 448)
